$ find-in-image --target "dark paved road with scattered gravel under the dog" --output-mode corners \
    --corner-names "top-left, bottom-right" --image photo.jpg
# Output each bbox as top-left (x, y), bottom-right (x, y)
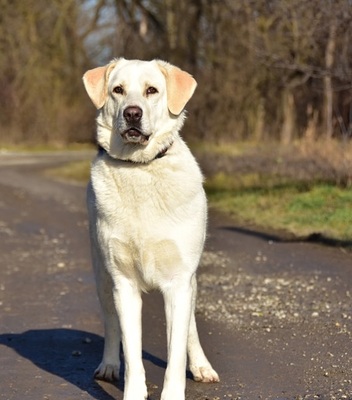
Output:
top-left (0, 153), bottom-right (352, 400)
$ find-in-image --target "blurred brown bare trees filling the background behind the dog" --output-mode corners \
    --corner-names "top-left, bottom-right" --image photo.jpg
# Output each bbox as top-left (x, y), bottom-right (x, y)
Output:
top-left (0, 0), bottom-right (352, 144)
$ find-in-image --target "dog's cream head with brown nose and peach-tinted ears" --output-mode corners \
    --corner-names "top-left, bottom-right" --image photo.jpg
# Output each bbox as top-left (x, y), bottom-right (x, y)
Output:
top-left (83, 58), bottom-right (197, 162)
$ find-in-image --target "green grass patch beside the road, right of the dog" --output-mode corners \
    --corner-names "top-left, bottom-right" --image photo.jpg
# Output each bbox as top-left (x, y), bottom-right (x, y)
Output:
top-left (205, 174), bottom-right (352, 241)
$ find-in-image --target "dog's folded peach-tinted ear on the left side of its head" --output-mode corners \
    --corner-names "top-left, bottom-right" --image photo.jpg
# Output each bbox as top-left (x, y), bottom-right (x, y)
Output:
top-left (83, 60), bottom-right (117, 109)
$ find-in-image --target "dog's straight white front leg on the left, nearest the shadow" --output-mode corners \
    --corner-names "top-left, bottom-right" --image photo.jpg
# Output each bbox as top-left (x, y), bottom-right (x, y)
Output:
top-left (114, 277), bottom-right (148, 400)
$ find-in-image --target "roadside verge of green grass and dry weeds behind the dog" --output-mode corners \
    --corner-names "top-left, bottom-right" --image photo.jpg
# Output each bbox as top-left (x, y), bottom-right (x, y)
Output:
top-left (47, 142), bottom-right (352, 247)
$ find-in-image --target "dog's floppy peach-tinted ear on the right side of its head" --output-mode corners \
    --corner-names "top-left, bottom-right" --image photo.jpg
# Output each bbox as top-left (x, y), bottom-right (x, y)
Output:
top-left (157, 60), bottom-right (197, 115)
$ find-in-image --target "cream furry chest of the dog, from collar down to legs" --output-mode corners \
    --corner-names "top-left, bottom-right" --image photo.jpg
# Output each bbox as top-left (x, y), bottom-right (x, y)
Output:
top-left (90, 153), bottom-right (206, 290)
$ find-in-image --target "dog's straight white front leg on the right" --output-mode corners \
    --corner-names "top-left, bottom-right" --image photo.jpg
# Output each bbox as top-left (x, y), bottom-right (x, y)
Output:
top-left (161, 277), bottom-right (193, 400)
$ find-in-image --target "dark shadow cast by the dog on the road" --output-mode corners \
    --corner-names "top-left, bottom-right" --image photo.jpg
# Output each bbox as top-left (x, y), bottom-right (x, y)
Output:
top-left (0, 329), bottom-right (166, 400)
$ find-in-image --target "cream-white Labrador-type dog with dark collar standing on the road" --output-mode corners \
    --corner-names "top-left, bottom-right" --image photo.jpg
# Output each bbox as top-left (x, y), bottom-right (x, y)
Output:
top-left (83, 58), bottom-right (219, 400)
